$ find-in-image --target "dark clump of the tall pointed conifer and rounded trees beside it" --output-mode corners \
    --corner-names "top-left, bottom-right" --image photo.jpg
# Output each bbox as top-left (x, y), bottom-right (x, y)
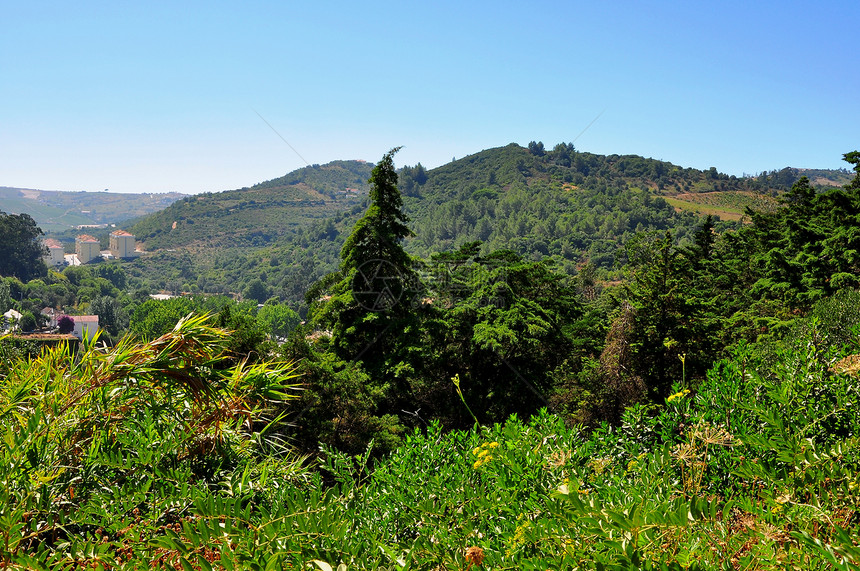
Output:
top-left (283, 154), bottom-right (602, 451)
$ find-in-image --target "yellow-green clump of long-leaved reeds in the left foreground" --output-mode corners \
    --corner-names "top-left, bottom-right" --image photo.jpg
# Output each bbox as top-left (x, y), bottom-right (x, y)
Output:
top-left (0, 318), bottom-right (304, 568)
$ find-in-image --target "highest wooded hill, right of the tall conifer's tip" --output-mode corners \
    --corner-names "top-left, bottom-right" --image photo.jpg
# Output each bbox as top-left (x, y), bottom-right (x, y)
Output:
top-left (401, 144), bottom-right (769, 273)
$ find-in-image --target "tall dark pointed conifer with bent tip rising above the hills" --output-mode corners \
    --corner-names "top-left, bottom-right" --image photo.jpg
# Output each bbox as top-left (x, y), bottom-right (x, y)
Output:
top-left (294, 148), bottom-right (421, 451)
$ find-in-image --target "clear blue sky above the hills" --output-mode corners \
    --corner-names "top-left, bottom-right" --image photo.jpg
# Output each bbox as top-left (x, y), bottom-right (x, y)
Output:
top-left (0, 0), bottom-right (860, 193)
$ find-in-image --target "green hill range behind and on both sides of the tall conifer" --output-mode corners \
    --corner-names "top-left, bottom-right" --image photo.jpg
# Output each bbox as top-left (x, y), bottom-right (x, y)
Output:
top-left (121, 144), bottom-right (852, 308)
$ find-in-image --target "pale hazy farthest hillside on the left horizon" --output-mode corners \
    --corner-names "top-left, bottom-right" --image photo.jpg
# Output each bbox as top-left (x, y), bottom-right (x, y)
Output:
top-left (0, 186), bottom-right (185, 232)
